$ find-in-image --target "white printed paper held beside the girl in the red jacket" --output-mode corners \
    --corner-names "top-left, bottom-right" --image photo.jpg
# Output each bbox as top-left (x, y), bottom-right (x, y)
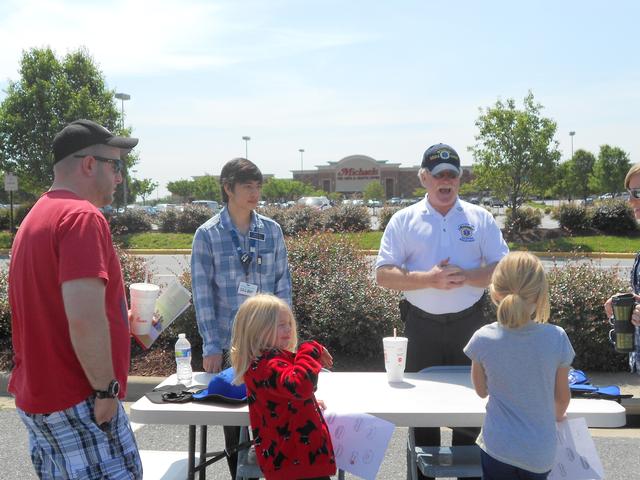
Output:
top-left (324, 410), bottom-right (395, 480)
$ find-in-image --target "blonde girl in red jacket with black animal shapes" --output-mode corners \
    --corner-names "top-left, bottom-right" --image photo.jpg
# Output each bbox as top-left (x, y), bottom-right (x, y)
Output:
top-left (231, 295), bottom-right (336, 480)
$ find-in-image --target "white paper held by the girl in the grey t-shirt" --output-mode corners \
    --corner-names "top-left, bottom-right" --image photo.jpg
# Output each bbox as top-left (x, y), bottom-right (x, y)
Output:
top-left (548, 417), bottom-right (604, 480)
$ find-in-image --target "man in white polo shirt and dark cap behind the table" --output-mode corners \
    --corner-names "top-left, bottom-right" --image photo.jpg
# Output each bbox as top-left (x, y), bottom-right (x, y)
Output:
top-left (376, 143), bottom-right (509, 478)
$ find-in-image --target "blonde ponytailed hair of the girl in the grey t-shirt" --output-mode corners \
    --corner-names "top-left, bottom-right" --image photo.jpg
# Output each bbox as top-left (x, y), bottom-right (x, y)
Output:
top-left (489, 252), bottom-right (550, 328)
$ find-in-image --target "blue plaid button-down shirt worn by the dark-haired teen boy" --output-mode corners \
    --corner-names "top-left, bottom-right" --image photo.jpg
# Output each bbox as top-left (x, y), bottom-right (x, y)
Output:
top-left (191, 208), bottom-right (291, 356)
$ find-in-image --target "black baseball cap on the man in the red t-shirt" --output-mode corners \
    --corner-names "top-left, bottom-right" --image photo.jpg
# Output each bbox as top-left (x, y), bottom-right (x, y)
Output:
top-left (53, 119), bottom-right (138, 163)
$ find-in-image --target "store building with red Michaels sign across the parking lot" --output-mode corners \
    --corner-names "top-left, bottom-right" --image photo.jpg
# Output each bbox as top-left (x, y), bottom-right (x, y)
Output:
top-left (292, 155), bottom-right (472, 198)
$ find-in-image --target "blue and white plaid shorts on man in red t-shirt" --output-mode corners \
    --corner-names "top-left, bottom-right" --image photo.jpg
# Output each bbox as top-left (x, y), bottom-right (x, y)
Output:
top-left (16, 396), bottom-right (142, 480)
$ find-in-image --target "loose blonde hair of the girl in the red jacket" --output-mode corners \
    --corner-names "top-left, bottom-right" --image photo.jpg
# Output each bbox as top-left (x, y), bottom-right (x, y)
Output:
top-left (230, 295), bottom-right (298, 385)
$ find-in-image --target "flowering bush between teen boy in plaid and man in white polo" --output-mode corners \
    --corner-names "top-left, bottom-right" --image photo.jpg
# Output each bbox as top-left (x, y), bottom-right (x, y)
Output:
top-left (287, 235), bottom-right (402, 365)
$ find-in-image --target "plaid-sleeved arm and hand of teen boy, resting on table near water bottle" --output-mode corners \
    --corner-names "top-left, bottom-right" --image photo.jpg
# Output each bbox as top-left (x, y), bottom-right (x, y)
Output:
top-left (191, 230), bottom-right (222, 373)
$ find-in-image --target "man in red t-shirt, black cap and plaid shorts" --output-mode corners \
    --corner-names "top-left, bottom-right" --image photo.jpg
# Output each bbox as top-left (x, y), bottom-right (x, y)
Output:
top-left (9, 120), bottom-right (142, 479)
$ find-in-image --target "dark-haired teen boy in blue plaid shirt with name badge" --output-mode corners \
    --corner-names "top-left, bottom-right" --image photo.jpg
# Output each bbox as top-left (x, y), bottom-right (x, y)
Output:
top-left (191, 158), bottom-right (291, 478)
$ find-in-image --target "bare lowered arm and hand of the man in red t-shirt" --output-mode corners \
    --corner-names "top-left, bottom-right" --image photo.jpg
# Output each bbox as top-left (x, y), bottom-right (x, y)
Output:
top-left (62, 278), bottom-right (118, 425)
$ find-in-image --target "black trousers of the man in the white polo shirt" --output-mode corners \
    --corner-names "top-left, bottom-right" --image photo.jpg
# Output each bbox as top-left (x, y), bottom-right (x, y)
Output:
top-left (400, 296), bottom-right (487, 480)
